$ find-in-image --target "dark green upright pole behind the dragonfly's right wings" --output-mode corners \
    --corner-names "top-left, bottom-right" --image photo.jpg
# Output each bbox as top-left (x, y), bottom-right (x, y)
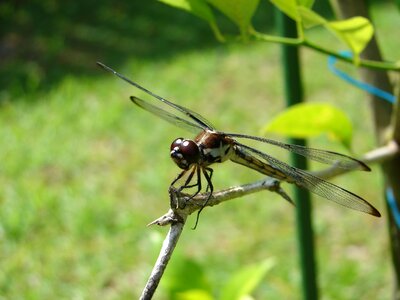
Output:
top-left (277, 11), bottom-right (318, 300)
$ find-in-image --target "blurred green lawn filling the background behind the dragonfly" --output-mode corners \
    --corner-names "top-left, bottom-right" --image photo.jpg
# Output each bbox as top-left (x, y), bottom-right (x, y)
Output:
top-left (0, 1), bottom-right (399, 299)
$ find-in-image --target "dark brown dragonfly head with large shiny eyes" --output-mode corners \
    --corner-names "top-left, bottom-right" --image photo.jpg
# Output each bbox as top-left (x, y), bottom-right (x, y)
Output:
top-left (170, 138), bottom-right (200, 170)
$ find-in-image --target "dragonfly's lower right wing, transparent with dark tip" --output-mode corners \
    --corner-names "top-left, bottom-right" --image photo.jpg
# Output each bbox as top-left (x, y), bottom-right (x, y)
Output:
top-left (236, 143), bottom-right (381, 217)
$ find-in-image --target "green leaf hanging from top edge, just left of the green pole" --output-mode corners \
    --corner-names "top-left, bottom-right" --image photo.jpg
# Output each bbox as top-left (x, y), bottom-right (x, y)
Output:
top-left (208, 0), bottom-right (259, 35)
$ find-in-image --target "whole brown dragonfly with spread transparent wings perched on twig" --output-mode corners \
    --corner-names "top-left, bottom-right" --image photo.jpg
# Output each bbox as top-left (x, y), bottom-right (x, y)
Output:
top-left (97, 62), bottom-right (381, 228)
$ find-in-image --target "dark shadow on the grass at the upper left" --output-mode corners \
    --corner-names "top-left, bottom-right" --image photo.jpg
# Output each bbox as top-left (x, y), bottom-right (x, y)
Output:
top-left (0, 0), bottom-right (334, 98)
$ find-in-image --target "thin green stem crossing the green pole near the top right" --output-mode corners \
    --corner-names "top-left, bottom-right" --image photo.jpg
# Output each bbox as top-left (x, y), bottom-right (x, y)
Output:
top-left (251, 31), bottom-right (400, 72)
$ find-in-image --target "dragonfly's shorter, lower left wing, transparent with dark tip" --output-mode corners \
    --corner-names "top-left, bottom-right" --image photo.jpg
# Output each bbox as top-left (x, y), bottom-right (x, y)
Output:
top-left (131, 96), bottom-right (203, 133)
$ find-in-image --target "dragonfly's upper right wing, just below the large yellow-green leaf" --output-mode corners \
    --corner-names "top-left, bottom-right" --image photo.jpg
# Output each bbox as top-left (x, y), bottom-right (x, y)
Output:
top-left (225, 133), bottom-right (371, 171)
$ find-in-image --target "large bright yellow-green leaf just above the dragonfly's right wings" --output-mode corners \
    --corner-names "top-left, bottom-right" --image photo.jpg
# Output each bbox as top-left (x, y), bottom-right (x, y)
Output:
top-left (264, 103), bottom-right (353, 148)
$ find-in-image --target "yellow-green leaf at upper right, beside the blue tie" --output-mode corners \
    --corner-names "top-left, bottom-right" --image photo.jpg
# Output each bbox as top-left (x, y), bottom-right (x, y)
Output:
top-left (325, 17), bottom-right (374, 64)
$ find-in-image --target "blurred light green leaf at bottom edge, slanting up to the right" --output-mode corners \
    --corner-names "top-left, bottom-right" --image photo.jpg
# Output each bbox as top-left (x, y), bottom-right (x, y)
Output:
top-left (220, 258), bottom-right (275, 300)
